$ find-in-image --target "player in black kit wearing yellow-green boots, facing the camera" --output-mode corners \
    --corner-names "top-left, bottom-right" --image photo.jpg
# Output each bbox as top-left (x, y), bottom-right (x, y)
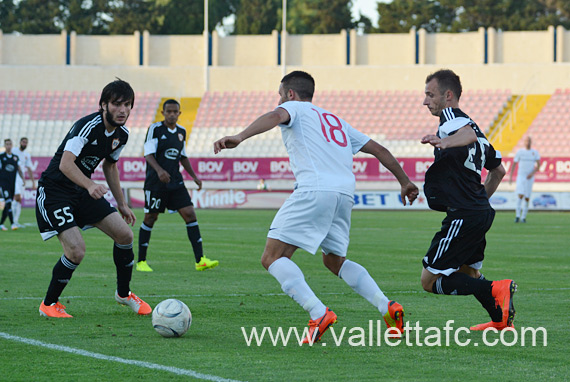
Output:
top-left (137, 99), bottom-right (219, 272)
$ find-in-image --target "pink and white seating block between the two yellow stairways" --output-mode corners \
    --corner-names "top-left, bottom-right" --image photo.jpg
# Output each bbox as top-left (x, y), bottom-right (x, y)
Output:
top-left (190, 90), bottom-right (511, 157)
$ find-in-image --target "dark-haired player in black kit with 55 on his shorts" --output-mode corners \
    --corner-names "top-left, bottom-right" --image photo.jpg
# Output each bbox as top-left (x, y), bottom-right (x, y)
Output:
top-left (36, 79), bottom-right (152, 317)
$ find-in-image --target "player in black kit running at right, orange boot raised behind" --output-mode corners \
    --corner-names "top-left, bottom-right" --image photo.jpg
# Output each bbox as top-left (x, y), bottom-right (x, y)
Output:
top-left (421, 70), bottom-right (516, 330)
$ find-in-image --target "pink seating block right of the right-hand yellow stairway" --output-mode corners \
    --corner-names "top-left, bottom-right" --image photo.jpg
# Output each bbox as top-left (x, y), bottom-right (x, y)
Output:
top-left (512, 89), bottom-right (570, 156)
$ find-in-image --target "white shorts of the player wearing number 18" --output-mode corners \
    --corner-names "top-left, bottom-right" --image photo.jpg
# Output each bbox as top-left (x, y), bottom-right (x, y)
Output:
top-left (267, 190), bottom-right (354, 257)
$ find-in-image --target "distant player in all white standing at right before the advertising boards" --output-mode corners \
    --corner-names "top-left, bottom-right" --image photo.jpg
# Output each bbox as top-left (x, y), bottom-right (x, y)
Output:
top-left (510, 137), bottom-right (540, 223)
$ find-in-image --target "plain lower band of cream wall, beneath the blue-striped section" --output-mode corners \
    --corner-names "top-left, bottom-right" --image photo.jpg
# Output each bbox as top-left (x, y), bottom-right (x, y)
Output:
top-left (0, 63), bottom-right (570, 97)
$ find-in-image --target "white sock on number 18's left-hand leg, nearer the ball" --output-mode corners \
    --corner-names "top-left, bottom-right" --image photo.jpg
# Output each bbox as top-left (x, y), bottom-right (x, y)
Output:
top-left (268, 257), bottom-right (327, 320)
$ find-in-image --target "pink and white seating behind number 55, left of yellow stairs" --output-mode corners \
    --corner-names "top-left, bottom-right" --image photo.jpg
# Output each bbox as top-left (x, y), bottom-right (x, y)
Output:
top-left (0, 90), bottom-right (160, 156)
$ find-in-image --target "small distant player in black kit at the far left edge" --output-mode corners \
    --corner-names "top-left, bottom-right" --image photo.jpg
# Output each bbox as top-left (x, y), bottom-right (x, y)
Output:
top-left (0, 138), bottom-right (23, 231)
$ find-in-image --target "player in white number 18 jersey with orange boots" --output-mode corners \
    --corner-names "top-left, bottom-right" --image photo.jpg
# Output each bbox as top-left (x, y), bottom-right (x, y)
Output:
top-left (214, 71), bottom-right (418, 343)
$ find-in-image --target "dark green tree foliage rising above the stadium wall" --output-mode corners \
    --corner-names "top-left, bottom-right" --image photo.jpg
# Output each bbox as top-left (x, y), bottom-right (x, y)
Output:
top-left (0, 0), bottom-right (570, 34)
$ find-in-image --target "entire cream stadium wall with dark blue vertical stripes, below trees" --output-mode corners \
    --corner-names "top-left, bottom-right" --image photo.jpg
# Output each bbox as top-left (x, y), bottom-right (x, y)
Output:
top-left (0, 27), bottom-right (570, 97)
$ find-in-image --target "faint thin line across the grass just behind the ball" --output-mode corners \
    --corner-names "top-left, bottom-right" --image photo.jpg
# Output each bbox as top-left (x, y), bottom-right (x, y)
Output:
top-left (0, 288), bottom-right (570, 301)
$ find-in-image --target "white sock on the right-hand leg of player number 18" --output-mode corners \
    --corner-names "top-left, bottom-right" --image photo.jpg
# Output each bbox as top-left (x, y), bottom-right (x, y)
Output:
top-left (338, 260), bottom-right (390, 315)
